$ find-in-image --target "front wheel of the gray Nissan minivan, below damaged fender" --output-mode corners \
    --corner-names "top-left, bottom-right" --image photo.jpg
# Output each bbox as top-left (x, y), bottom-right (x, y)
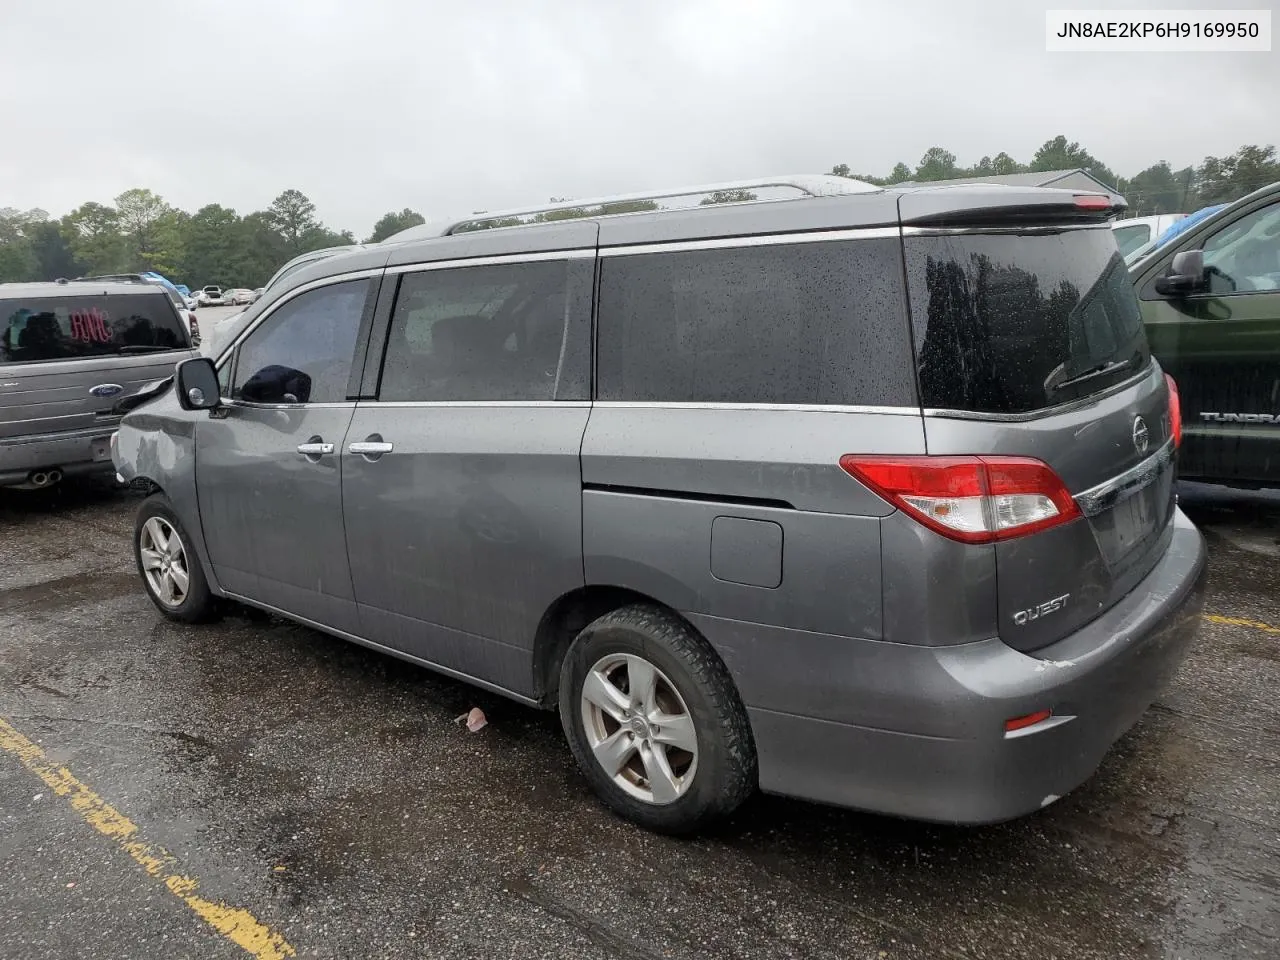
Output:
top-left (133, 493), bottom-right (218, 623)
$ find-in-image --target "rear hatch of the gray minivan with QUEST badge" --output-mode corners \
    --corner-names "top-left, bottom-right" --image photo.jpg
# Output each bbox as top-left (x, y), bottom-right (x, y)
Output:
top-left (904, 195), bottom-right (1174, 650)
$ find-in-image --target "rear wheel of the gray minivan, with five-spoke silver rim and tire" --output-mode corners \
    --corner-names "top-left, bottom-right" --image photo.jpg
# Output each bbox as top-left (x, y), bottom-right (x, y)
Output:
top-left (559, 604), bottom-right (756, 833)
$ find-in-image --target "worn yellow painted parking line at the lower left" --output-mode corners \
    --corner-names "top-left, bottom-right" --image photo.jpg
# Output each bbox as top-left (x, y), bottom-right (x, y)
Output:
top-left (0, 717), bottom-right (297, 960)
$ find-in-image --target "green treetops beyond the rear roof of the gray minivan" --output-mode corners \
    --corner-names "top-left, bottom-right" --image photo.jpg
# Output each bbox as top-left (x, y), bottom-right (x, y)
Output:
top-left (831, 136), bottom-right (1280, 216)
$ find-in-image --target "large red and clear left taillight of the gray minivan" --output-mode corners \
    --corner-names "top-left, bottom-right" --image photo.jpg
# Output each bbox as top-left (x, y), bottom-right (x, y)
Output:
top-left (840, 453), bottom-right (1080, 543)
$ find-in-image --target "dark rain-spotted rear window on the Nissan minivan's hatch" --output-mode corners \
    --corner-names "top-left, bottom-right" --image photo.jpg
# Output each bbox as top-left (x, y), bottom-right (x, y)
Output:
top-left (905, 229), bottom-right (1151, 413)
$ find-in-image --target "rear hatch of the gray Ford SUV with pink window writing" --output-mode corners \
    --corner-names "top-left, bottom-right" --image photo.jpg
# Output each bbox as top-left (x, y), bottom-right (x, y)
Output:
top-left (0, 288), bottom-right (192, 440)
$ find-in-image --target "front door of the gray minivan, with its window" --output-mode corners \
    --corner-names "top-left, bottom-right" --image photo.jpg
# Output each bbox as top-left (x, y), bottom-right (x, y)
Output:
top-left (196, 279), bottom-right (376, 632)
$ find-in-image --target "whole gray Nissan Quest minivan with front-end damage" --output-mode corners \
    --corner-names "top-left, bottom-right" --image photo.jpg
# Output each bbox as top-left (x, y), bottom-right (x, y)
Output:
top-left (114, 178), bottom-right (1206, 831)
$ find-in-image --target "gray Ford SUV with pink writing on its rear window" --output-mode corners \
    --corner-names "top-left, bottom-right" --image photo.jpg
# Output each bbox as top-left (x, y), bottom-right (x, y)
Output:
top-left (0, 282), bottom-right (196, 489)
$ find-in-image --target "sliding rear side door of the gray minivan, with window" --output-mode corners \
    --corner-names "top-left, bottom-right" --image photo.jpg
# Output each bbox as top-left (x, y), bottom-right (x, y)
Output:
top-left (342, 253), bottom-right (593, 694)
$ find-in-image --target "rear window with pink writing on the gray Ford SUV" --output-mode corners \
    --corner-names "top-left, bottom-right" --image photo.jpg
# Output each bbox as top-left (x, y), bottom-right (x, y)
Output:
top-left (0, 293), bottom-right (188, 364)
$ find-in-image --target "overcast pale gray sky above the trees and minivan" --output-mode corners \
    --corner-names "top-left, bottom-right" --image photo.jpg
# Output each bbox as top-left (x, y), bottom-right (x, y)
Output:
top-left (0, 0), bottom-right (1280, 237)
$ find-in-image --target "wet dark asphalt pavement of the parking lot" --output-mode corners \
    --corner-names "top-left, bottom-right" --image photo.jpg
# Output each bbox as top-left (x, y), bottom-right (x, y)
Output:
top-left (0, 481), bottom-right (1280, 960)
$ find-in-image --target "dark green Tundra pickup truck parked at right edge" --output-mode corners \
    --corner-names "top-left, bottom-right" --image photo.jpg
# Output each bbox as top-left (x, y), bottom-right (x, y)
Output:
top-left (1129, 183), bottom-right (1280, 486)
